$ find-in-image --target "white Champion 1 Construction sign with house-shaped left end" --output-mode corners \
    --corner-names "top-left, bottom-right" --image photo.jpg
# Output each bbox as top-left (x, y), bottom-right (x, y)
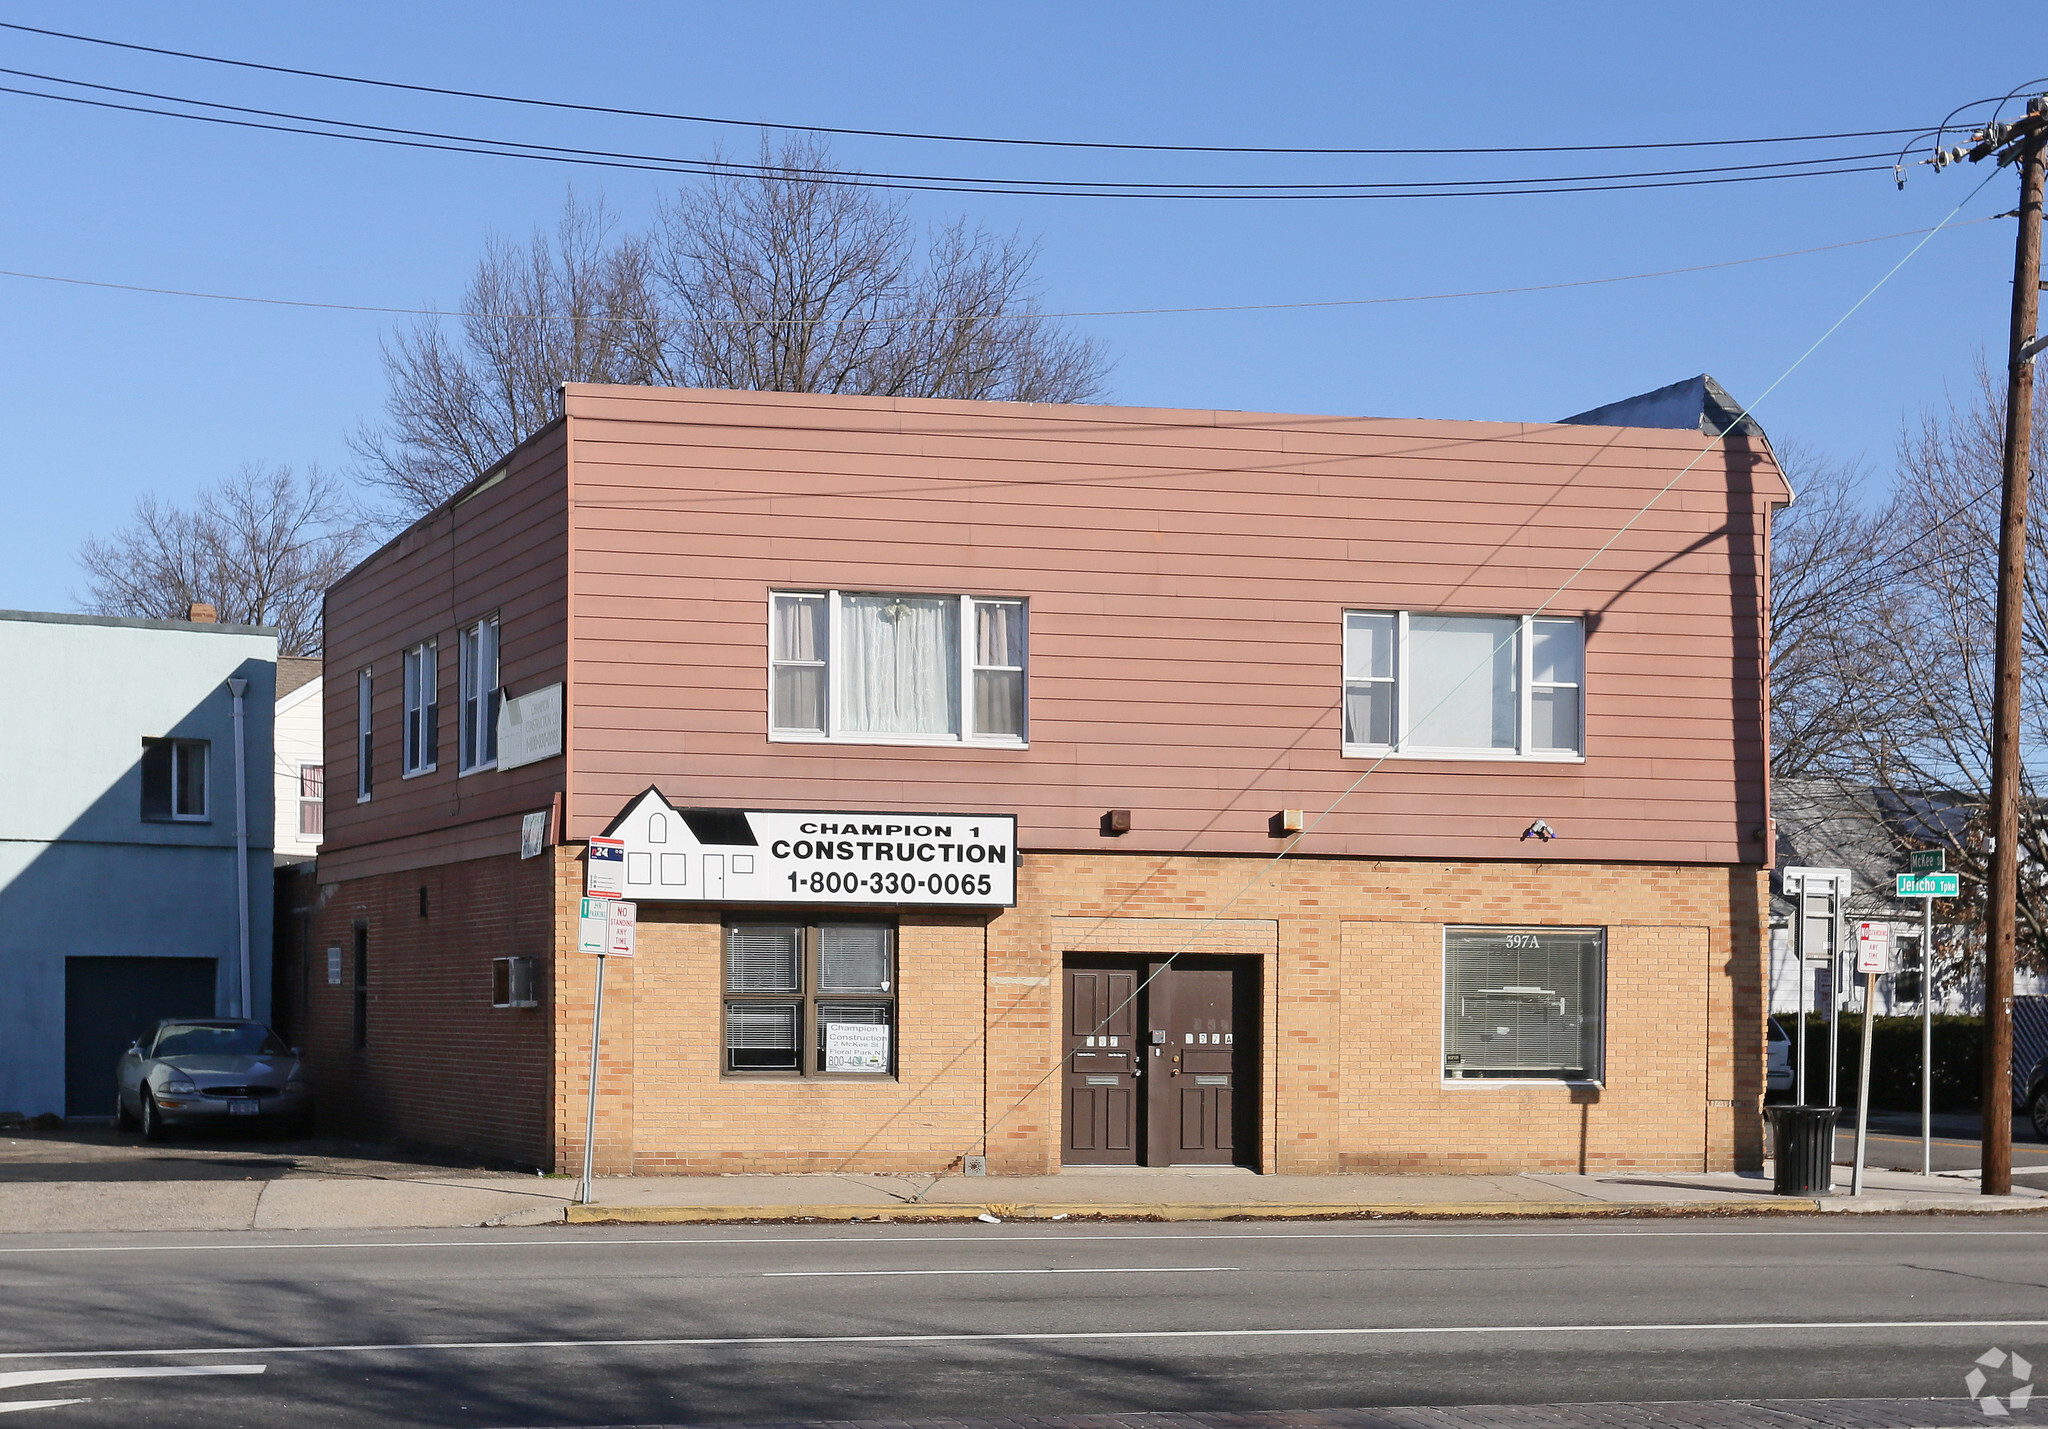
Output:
top-left (588, 788), bottom-right (1018, 907)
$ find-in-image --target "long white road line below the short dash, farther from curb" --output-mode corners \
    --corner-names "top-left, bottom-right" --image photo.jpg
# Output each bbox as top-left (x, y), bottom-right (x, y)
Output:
top-left (0, 1320), bottom-right (2048, 1359)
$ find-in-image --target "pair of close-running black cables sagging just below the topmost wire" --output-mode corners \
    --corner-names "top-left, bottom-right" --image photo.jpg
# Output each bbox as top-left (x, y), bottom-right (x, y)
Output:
top-left (0, 70), bottom-right (1892, 201)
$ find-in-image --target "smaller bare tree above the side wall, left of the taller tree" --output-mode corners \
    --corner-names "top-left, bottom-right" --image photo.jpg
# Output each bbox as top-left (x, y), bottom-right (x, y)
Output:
top-left (352, 194), bottom-right (649, 520)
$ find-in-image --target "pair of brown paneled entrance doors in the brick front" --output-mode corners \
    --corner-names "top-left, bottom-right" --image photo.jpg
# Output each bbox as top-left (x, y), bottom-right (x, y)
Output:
top-left (1061, 958), bottom-right (1260, 1167)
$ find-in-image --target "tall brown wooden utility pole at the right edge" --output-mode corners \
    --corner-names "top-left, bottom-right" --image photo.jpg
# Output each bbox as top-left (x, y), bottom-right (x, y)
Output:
top-left (1980, 98), bottom-right (2048, 1196)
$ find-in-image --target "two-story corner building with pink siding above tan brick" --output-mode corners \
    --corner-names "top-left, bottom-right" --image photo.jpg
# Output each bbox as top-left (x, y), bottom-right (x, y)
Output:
top-left (301, 379), bottom-right (1790, 1173)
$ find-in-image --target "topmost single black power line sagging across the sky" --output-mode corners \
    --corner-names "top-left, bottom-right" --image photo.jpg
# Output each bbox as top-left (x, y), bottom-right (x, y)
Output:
top-left (0, 20), bottom-right (1925, 156)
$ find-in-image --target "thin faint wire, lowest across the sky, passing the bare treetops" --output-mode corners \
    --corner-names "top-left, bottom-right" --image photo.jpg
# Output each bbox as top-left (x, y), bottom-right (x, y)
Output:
top-left (0, 217), bottom-right (1993, 328)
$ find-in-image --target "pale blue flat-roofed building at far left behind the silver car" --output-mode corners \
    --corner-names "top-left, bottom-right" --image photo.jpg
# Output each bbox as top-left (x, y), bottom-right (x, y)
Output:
top-left (0, 606), bottom-right (276, 1118)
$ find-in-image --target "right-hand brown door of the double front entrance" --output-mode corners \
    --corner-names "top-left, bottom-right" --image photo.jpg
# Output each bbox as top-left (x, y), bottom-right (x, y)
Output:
top-left (1145, 966), bottom-right (1239, 1167)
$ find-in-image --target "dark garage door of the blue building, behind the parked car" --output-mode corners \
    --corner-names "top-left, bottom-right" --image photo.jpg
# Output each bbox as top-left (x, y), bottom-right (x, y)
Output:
top-left (63, 958), bottom-right (219, 1116)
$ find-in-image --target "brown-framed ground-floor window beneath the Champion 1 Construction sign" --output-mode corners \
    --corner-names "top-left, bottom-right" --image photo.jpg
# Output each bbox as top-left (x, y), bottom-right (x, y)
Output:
top-left (725, 921), bottom-right (897, 1077)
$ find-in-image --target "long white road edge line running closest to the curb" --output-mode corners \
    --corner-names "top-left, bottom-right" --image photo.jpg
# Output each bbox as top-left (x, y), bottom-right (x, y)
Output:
top-left (0, 1206), bottom-right (2048, 1255)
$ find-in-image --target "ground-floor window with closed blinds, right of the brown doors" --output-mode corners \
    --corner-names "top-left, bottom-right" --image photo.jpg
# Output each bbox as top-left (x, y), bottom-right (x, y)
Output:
top-left (1444, 927), bottom-right (1606, 1081)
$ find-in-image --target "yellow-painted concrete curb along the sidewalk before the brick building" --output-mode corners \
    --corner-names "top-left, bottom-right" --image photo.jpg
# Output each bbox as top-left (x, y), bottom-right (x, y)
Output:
top-left (563, 1196), bottom-right (1821, 1226)
